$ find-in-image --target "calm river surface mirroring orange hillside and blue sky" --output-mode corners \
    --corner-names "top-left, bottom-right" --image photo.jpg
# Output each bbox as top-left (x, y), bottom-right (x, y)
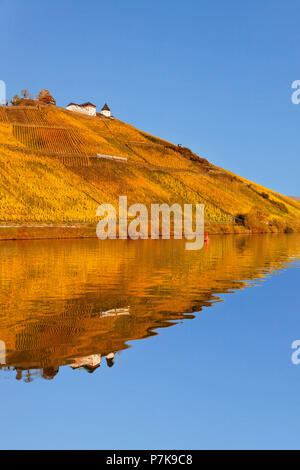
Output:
top-left (0, 234), bottom-right (300, 449)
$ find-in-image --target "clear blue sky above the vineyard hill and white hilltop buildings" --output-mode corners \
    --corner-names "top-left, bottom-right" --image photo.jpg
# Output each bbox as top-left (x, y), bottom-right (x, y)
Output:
top-left (0, 0), bottom-right (300, 196)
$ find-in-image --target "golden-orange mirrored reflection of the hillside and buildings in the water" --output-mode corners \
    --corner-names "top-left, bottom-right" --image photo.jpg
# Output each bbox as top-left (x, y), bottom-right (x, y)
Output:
top-left (0, 234), bottom-right (300, 380)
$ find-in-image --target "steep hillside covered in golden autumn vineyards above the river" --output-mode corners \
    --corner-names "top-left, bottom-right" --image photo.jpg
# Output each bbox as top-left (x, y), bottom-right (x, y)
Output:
top-left (0, 105), bottom-right (300, 232)
